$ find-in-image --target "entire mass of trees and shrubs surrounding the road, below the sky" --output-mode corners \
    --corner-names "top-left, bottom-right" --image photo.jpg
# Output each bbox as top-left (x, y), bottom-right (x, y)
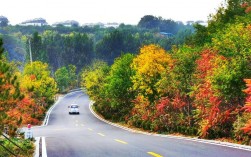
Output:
top-left (0, 0), bottom-right (251, 153)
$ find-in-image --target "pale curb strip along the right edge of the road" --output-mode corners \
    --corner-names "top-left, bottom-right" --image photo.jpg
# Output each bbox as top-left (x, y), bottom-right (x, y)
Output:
top-left (89, 101), bottom-right (251, 152)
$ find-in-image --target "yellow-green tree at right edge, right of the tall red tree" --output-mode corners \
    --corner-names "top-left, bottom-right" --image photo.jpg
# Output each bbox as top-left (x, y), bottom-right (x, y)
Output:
top-left (212, 24), bottom-right (251, 106)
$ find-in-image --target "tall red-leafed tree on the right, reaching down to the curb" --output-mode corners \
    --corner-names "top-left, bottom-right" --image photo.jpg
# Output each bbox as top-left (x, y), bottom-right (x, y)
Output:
top-left (192, 50), bottom-right (236, 138)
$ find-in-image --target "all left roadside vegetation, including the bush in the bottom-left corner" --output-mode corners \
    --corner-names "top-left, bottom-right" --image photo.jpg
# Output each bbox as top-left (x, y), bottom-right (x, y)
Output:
top-left (0, 39), bottom-right (57, 157)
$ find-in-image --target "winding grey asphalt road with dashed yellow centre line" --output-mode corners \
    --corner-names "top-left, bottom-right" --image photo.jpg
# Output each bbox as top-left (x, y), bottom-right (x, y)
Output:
top-left (33, 91), bottom-right (251, 157)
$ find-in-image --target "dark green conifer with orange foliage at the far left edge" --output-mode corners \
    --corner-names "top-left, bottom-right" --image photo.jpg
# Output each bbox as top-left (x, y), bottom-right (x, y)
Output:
top-left (0, 39), bottom-right (23, 135)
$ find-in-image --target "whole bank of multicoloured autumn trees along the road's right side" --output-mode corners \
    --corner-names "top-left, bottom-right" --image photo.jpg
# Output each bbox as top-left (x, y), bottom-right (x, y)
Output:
top-left (82, 0), bottom-right (251, 144)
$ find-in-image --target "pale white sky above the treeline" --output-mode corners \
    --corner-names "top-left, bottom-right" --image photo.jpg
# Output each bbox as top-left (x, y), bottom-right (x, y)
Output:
top-left (0, 0), bottom-right (224, 25)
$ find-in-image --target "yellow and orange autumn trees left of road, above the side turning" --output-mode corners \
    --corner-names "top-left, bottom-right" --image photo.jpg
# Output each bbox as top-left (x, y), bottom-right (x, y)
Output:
top-left (0, 40), bottom-right (57, 136)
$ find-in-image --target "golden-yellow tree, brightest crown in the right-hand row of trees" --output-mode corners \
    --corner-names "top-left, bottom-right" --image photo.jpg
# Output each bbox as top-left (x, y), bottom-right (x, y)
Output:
top-left (132, 44), bottom-right (173, 102)
